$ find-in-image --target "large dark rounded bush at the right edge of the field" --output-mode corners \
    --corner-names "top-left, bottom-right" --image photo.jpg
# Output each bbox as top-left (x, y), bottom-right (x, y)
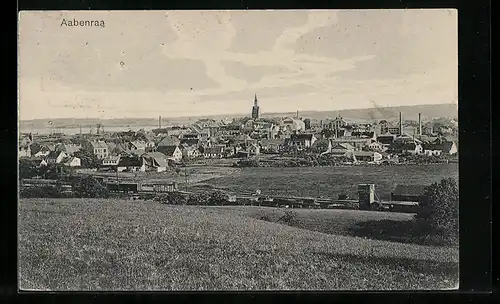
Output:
top-left (417, 178), bottom-right (459, 241)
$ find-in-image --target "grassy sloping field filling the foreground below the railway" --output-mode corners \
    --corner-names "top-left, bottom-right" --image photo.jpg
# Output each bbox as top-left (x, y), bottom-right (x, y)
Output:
top-left (19, 199), bottom-right (458, 290)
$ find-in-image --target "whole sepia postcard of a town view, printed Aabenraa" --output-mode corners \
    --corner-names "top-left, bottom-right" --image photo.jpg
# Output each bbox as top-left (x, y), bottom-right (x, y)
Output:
top-left (17, 9), bottom-right (458, 291)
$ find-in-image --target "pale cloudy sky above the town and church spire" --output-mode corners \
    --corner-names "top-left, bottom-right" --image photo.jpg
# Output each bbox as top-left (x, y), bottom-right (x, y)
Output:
top-left (19, 10), bottom-right (458, 120)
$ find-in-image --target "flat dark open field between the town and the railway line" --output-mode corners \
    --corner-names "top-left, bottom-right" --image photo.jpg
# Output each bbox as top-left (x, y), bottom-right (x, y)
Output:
top-left (204, 164), bottom-right (458, 199)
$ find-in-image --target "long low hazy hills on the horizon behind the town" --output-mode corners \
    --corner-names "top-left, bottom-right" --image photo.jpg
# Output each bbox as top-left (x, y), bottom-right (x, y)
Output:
top-left (19, 104), bottom-right (458, 130)
